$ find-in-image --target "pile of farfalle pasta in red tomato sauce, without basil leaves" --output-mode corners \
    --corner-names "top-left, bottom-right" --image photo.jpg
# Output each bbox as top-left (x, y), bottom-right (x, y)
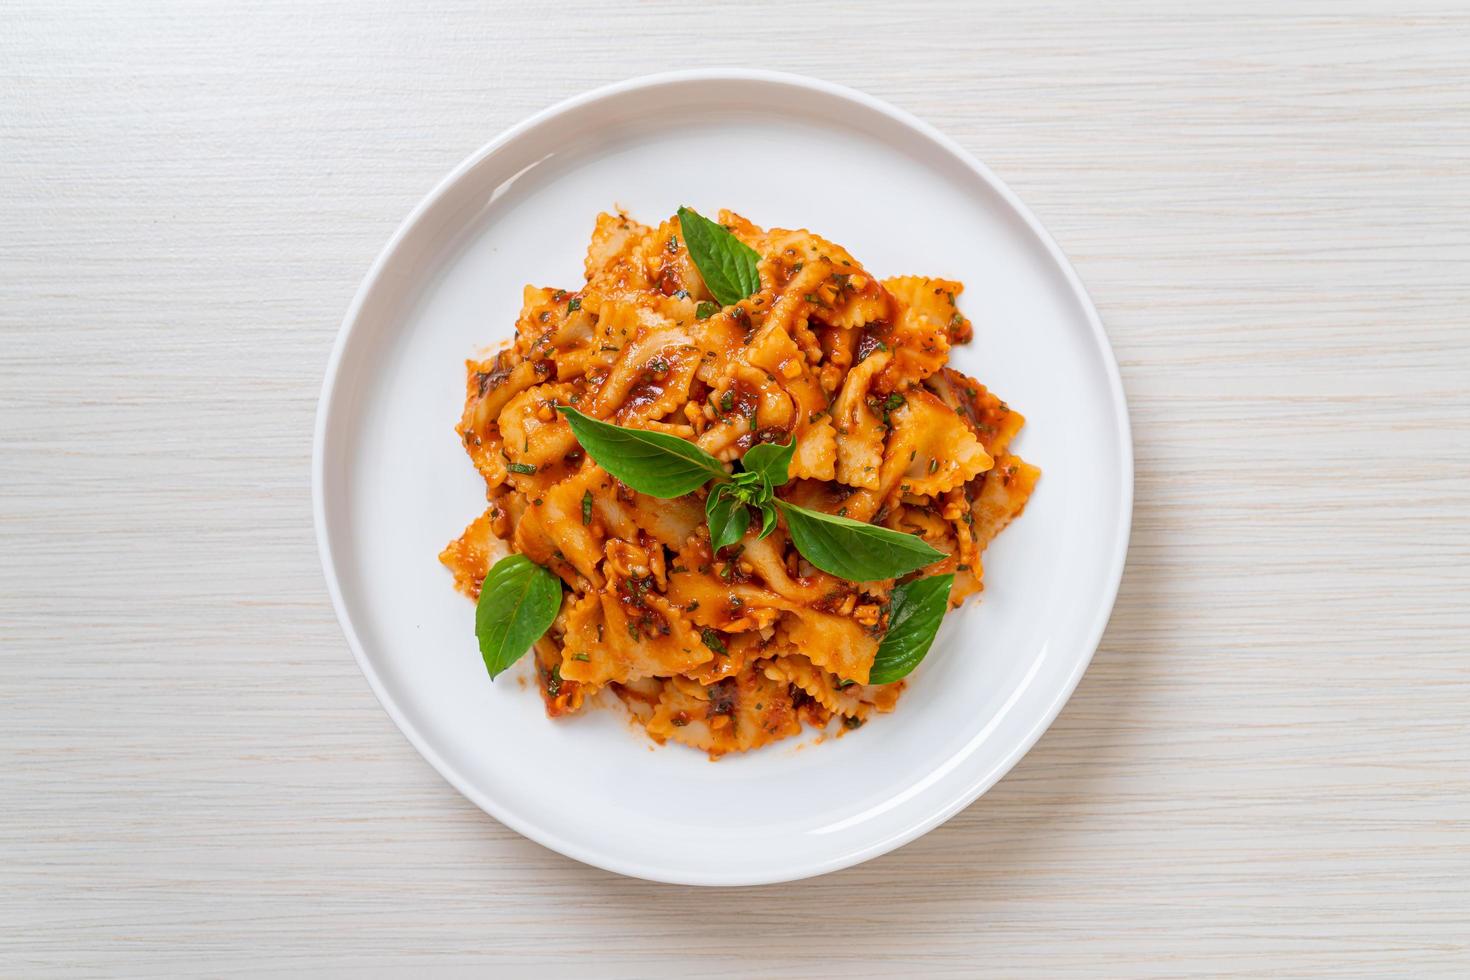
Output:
top-left (440, 212), bottom-right (1039, 757)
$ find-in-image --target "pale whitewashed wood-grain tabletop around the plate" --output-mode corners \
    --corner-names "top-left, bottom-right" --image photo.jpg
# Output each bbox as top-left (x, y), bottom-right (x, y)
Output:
top-left (0, 0), bottom-right (1470, 977)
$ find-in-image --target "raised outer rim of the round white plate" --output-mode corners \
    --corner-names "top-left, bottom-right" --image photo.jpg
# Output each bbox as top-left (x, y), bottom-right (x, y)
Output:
top-left (312, 68), bottom-right (1135, 886)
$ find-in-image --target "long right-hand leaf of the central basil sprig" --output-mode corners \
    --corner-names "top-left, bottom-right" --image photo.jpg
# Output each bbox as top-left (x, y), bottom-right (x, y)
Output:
top-left (776, 500), bottom-right (947, 582)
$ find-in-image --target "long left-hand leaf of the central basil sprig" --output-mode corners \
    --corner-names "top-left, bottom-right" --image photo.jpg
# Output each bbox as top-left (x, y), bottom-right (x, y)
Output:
top-left (557, 406), bottom-right (728, 498)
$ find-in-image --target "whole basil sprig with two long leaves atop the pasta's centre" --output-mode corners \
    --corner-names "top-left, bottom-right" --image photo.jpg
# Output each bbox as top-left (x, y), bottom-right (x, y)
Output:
top-left (557, 406), bottom-right (945, 582)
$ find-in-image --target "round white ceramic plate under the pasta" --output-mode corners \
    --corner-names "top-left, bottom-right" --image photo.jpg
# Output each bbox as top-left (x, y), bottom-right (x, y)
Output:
top-left (313, 71), bottom-right (1133, 884)
